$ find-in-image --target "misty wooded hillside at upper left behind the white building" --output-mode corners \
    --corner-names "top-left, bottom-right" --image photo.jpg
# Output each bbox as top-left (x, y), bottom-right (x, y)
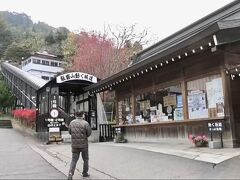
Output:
top-left (0, 11), bottom-right (70, 61)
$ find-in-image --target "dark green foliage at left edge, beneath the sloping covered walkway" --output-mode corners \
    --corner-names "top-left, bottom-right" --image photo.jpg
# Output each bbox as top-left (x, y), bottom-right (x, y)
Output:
top-left (0, 77), bottom-right (15, 112)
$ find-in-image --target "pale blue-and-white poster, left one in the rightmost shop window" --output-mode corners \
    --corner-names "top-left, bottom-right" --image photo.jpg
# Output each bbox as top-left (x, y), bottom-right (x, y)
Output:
top-left (188, 93), bottom-right (208, 119)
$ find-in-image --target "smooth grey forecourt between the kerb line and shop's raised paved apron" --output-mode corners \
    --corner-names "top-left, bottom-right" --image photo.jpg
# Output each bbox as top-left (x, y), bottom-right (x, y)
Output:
top-left (44, 143), bottom-right (240, 179)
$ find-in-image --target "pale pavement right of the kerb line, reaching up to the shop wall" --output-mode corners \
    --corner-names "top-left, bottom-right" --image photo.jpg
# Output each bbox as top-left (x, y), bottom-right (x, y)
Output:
top-left (5, 119), bottom-right (240, 179)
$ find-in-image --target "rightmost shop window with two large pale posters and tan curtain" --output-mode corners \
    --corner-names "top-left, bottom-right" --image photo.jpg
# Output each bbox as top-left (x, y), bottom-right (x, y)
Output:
top-left (187, 75), bottom-right (224, 119)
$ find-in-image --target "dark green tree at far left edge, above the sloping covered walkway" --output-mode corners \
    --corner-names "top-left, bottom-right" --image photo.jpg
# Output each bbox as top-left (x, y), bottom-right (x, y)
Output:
top-left (0, 18), bottom-right (12, 59)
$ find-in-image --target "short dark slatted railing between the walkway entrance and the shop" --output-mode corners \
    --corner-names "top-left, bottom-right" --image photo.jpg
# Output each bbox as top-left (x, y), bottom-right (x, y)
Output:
top-left (99, 124), bottom-right (116, 142)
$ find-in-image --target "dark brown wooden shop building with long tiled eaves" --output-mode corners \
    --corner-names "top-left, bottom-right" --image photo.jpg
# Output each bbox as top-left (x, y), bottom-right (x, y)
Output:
top-left (86, 1), bottom-right (240, 147)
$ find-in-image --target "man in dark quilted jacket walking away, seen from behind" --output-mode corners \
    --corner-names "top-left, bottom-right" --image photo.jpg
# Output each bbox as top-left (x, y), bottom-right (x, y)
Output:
top-left (68, 111), bottom-right (92, 179)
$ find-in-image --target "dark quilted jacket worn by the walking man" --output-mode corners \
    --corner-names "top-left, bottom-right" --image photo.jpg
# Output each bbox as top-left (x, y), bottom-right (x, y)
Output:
top-left (68, 118), bottom-right (92, 148)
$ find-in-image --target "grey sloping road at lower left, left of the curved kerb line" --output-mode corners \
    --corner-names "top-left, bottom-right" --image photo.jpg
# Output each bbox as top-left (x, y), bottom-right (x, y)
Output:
top-left (0, 128), bottom-right (66, 179)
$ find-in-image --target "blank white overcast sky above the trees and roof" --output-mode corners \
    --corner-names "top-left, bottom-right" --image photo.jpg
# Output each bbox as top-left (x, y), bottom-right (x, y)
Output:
top-left (0, 0), bottom-right (233, 45)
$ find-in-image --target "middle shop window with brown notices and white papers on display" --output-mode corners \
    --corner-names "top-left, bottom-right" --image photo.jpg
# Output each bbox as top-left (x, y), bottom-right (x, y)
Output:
top-left (135, 84), bottom-right (183, 123)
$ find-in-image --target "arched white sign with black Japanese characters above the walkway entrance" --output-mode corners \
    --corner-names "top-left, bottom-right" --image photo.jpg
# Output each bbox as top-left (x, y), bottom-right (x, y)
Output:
top-left (56, 72), bottom-right (97, 83)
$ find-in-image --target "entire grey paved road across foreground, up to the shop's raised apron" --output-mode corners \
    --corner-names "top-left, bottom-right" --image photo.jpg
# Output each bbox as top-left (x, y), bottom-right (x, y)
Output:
top-left (0, 119), bottom-right (240, 179)
